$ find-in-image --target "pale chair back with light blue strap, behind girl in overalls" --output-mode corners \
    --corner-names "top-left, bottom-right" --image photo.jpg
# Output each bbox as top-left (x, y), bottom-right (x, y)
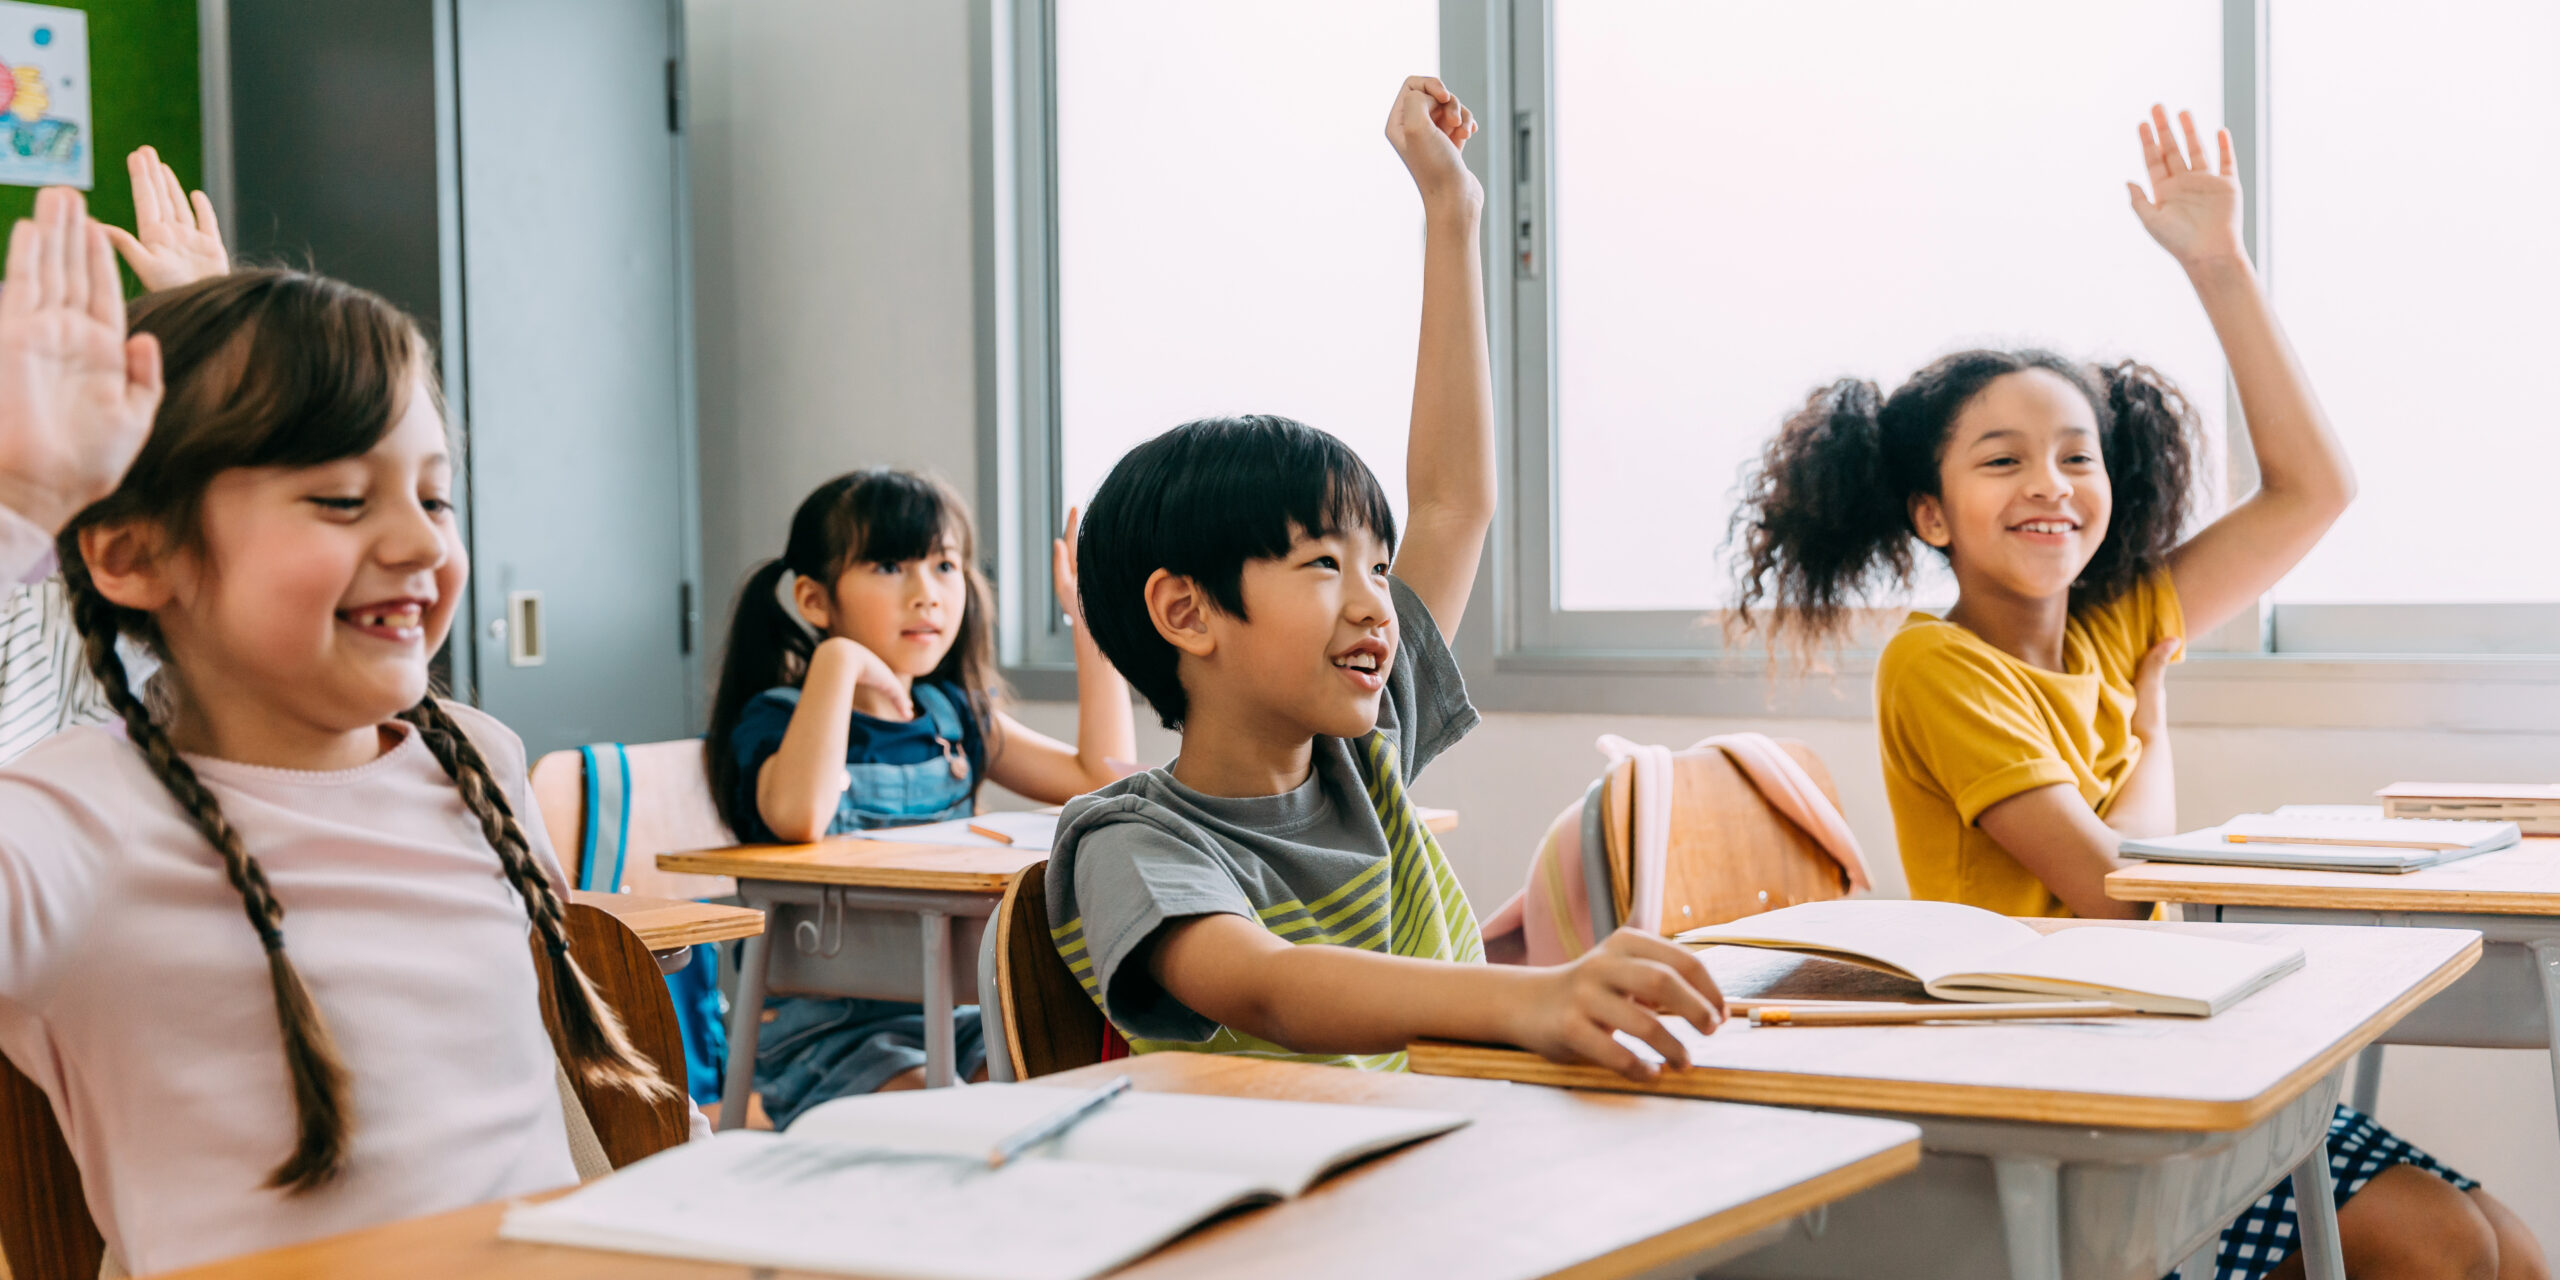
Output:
top-left (532, 737), bottom-right (737, 899)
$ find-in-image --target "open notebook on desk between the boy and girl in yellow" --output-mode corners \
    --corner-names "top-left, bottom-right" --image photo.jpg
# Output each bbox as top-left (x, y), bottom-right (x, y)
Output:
top-left (1679, 899), bottom-right (2301, 1016)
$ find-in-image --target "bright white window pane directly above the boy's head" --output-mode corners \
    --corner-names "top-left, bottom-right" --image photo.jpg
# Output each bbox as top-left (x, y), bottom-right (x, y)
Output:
top-left (1055, 0), bottom-right (1439, 522)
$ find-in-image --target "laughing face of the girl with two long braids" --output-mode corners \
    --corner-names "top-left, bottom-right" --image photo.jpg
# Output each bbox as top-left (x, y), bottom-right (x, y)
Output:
top-left (84, 376), bottom-right (468, 750)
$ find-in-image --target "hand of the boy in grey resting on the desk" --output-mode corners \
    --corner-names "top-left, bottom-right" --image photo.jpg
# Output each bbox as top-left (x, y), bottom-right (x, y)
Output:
top-left (1513, 929), bottom-right (1725, 1080)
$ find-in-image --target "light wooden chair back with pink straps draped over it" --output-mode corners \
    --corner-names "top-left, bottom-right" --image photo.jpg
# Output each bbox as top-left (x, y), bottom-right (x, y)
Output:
top-left (1600, 740), bottom-right (1848, 937)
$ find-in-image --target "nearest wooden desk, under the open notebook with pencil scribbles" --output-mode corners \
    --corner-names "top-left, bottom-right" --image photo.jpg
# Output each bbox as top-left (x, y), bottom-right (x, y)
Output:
top-left (149, 1052), bottom-right (1920, 1280)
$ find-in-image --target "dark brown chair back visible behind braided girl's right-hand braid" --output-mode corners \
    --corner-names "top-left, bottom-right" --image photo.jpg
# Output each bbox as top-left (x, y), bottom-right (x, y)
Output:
top-left (532, 901), bottom-right (694, 1170)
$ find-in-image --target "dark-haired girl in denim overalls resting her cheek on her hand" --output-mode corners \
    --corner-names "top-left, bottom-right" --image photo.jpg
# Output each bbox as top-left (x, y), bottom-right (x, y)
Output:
top-left (704, 471), bottom-right (1137, 1126)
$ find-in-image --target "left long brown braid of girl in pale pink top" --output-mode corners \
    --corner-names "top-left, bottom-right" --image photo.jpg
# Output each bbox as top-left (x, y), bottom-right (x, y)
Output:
top-left (64, 570), bottom-right (351, 1196)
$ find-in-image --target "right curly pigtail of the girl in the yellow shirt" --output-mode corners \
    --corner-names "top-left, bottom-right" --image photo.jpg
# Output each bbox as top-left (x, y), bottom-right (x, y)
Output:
top-left (2071, 361), bottom-right (2196, 609)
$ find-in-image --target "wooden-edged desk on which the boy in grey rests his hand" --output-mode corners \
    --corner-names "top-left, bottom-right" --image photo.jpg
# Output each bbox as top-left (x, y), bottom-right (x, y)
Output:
top-left (1411, 922), bottom-right (2481, 1280)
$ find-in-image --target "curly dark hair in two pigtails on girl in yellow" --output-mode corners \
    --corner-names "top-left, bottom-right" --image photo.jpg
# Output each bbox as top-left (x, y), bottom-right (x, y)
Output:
top-left (1725, 348), bottom-right (2194, 653)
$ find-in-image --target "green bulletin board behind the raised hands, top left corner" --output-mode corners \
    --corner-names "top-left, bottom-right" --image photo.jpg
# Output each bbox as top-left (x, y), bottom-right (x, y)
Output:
top-left (0, 0), bottom-right (198, 279)
